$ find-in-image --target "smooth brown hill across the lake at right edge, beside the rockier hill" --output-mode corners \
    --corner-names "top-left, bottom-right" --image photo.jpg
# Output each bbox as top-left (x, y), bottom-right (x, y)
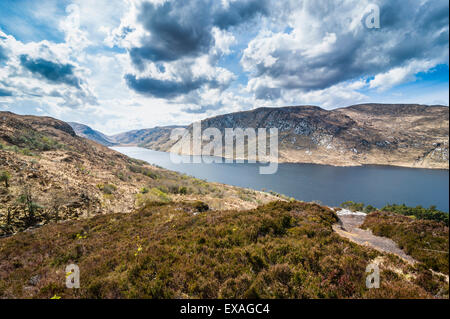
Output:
top-left (337, 104), bottom-right (449, 169)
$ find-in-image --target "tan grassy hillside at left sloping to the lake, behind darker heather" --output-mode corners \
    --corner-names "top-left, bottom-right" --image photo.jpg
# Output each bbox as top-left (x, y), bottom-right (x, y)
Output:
top-left (0, 112), bottom-right (275, 237)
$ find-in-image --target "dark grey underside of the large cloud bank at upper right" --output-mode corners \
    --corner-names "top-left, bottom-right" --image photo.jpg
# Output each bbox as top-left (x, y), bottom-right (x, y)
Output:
top-left (242, 0), bottom-right (449, 100)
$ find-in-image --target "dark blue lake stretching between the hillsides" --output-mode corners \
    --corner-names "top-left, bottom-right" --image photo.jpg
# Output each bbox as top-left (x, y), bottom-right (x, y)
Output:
top-left (113, 147), bottom-right (449, 212)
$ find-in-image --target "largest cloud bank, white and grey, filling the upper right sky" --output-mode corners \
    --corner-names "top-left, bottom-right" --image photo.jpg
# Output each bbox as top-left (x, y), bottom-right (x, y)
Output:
top-left (241, 0), bottom-right (448, 100)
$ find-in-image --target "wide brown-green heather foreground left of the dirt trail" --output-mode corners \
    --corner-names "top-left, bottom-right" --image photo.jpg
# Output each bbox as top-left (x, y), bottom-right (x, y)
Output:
top-left (0, 201), bottom-right (448, 298)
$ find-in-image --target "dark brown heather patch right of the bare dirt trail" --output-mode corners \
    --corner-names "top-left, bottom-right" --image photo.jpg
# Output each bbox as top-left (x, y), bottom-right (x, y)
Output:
top-left (361, 212), bottom-right (449, 274)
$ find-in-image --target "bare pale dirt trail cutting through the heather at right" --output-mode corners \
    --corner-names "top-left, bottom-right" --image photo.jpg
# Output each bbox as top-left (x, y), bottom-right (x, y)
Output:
top-left (333, 212), bottom-right (417, 264)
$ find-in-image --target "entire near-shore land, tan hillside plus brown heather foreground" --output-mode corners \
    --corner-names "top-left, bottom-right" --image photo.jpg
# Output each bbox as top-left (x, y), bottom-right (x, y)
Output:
top-left (0, 112), bottom-right (448, 299)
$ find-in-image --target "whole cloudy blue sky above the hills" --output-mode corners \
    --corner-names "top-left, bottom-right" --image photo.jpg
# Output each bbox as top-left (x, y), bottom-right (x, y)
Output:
top-left (0, 0), bottom-right (449, 134)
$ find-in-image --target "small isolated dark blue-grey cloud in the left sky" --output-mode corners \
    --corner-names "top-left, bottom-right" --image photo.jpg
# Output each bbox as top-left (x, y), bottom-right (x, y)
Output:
top-left (20, 55), bottom-right (81, 89)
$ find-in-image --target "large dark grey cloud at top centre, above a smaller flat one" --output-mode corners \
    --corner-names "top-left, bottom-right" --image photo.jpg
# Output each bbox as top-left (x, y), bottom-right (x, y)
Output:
top-left (130, 0), bottom-right (268, 68)
